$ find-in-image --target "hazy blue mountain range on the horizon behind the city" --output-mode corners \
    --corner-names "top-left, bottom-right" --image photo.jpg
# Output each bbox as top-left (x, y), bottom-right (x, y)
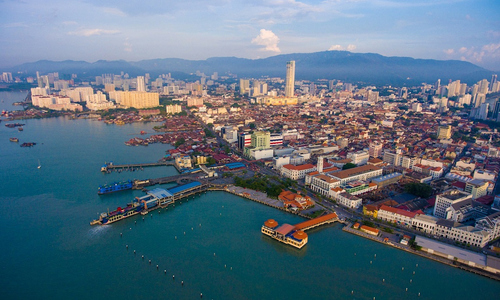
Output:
top-left (11, 51), bottom-right (494, 85)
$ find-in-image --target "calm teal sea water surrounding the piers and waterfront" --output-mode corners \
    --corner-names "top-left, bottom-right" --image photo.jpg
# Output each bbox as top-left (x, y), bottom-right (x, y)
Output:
top-left (0, 92), bottom-right (500, 299)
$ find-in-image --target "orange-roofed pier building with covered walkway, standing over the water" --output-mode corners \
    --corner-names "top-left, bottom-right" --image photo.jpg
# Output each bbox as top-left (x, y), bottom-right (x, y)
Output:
top-left (261, 213), bottom-right (339, 249)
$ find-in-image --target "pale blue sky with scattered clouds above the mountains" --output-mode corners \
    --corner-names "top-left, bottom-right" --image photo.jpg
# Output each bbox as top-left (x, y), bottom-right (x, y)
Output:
top-left (0, 0), bottom-right (500, 71)
